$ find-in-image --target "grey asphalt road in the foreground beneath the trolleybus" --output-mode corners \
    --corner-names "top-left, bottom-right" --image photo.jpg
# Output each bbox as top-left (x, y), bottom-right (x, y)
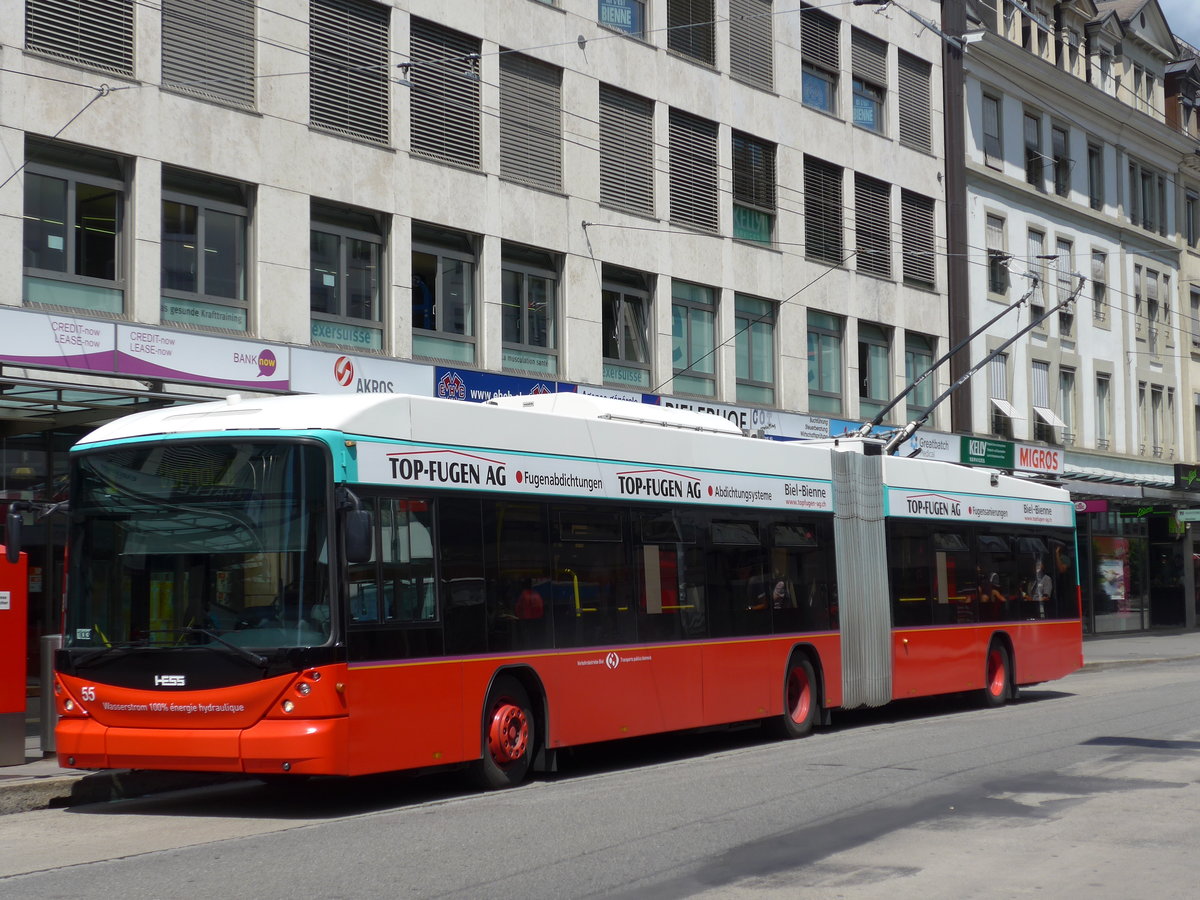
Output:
top-left (0, 660), bottom-right (1200, 900)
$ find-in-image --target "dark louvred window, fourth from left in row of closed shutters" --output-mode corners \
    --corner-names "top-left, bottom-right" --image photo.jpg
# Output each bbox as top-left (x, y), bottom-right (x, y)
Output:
top-left (410, 18), bottom-right (480, 169)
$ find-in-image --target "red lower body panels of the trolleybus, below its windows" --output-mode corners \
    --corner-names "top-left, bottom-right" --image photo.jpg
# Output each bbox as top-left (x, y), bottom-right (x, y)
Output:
top-left (56, 620), bottom-right (1082, 775)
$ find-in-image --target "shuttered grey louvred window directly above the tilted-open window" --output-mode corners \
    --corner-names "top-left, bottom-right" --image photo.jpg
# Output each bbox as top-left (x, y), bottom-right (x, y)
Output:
top-left (600, 84), bottom-right (654, 216)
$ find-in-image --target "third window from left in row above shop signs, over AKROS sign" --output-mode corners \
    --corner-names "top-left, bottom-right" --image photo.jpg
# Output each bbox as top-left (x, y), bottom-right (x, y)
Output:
top-left (308, 200), bottom-right (384, 350)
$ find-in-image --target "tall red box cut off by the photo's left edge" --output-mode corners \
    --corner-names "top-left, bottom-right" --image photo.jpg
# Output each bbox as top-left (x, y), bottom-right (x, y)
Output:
top-left (0, 546), bottom-right (28, 766)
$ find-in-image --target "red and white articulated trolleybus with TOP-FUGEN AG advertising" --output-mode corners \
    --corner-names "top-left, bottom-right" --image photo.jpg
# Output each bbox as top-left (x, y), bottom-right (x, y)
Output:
top-left (44, 394), bottom-right (1082, 787)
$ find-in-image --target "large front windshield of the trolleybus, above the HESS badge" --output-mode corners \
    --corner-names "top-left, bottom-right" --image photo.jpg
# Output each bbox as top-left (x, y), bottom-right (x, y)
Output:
top-left (65, 439), bottom-right (330, 649)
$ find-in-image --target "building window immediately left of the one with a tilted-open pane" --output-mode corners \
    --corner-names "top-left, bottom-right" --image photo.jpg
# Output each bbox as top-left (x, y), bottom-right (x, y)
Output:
top-left (500, 244), bottom-right (559, 376)
